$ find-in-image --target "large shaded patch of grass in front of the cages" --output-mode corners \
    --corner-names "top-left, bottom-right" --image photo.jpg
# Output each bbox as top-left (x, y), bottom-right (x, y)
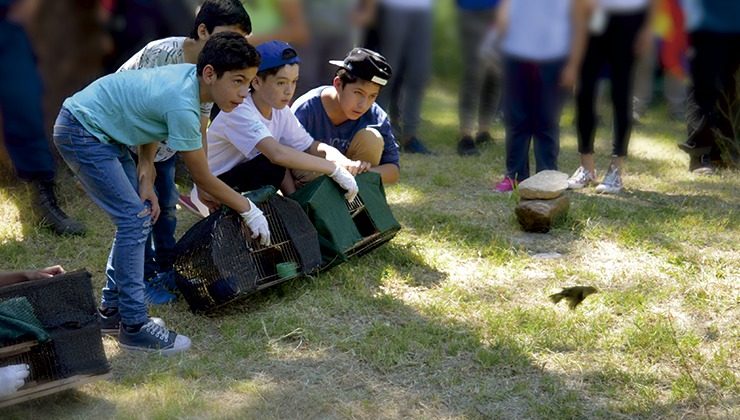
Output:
top-left (4, 238), bottom-right (587, 418)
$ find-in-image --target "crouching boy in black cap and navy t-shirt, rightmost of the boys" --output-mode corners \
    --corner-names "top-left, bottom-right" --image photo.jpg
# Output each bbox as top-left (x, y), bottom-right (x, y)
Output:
top-left (292, 48), bottom-right (400, 184)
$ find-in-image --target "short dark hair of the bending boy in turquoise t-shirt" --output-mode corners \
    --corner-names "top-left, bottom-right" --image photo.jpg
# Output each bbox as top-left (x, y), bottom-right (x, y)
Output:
top-left (197, 32), bottom-right (260, 77)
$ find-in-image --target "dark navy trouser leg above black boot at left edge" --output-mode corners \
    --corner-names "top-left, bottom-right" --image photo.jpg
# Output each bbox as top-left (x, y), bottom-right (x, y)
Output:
top-left (0, 20), bottom-right (55, 181)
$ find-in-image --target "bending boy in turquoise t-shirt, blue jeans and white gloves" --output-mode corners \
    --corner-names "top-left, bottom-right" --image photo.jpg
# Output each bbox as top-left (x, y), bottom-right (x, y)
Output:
top-left (54, 32), bottom-right (270, 355)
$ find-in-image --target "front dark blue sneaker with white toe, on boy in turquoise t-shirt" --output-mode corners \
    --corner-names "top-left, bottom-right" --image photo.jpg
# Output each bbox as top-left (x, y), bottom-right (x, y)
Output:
top-left (118, 320), bottom-right (191, 356)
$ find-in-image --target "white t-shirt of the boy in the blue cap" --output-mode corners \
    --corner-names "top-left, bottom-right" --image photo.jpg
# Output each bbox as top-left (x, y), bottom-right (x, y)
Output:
top-left (208, 95), bottom-right (313, 176)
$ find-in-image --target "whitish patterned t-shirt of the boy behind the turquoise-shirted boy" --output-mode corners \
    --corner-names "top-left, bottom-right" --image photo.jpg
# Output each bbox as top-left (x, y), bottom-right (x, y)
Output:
top-left (116, 36), bottom-right (213, 162)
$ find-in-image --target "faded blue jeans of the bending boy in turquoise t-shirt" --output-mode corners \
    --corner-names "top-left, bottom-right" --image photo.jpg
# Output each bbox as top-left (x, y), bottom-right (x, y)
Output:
top-left (54, 108), bottom-right (152, 325)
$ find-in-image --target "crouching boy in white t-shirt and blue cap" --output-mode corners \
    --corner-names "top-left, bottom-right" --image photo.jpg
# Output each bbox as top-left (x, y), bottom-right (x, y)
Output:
top-left (193, 41), bottom-right (362, 214)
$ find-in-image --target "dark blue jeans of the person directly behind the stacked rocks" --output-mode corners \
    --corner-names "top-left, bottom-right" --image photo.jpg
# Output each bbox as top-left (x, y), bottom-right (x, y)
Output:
top-left (503, 57), bottom-right (564, 181)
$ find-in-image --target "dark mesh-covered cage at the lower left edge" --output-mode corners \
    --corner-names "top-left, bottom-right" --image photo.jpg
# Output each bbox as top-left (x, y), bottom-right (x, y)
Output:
top-left (0, 270), bottom-right (110, 407)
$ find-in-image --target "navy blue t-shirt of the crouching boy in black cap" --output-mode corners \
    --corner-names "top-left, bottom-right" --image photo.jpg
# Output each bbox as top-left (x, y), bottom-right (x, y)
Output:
top-left (291, 86), bottom-right (401, 167)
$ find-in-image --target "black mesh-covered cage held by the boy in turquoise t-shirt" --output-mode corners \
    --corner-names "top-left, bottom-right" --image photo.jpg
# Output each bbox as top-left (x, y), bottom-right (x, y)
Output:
top-left (174, 195), bottom-right (321, 312)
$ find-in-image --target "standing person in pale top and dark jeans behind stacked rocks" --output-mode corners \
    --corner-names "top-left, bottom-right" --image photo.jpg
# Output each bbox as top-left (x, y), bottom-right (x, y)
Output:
top-left (494, 0), bottom-right (590, 193)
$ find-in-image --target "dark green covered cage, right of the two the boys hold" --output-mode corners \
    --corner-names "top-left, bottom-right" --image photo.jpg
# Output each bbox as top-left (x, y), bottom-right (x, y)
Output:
top-left (290, 172), bottom-right (401, 269)
